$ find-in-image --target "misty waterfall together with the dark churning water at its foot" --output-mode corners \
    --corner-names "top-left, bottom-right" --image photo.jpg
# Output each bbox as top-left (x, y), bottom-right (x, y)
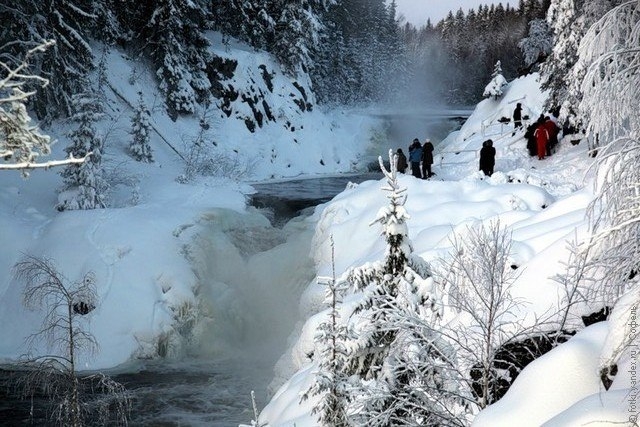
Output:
top-left (111, 208), bottom-right (315, 427)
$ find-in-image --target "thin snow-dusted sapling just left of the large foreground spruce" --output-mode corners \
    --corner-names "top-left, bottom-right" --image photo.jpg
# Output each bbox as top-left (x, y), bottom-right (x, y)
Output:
top-left (301, 236), bottom-right (352, 427)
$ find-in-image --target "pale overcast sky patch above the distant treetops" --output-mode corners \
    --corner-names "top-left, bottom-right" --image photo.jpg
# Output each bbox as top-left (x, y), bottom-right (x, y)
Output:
top-left (396, 0), bottom-right (518, 27)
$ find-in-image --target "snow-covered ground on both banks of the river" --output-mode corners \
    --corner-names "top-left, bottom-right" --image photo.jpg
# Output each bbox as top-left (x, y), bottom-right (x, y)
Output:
top-left (0, 38), bottom-right (631, 427)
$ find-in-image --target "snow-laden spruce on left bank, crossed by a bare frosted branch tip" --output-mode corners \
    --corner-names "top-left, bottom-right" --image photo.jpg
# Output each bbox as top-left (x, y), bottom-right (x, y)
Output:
top-left (56, 92), bottom-right (108, 211)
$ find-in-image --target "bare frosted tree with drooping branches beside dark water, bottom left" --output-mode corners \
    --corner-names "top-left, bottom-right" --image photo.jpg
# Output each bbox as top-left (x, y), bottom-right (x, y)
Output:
top-left (13, 256), bottom-right (130, 427)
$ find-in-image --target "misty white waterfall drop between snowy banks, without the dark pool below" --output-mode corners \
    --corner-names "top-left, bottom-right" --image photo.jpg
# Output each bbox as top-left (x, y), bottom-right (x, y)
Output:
top-left (195, 209), bottom-right (315, 361)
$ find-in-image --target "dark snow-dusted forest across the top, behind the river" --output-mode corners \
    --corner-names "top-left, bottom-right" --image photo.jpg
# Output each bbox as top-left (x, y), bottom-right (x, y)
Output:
top-left (0, 0), bottom-right (548, 124)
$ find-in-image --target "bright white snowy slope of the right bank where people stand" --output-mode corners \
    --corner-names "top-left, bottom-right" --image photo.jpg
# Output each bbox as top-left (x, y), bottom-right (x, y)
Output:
top-left (260, 75), bottom-right (606, 427)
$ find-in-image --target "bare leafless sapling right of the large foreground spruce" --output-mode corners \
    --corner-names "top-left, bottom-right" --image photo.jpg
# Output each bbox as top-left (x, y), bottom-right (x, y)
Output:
top-left (437, 221), bottom-right (524, 409)
